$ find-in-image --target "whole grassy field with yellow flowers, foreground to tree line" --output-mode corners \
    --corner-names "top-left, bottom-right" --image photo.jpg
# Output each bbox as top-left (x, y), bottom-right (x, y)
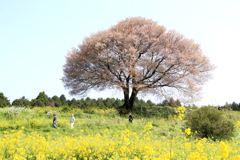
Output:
top-left (0, 107), bottom-right (240, 160)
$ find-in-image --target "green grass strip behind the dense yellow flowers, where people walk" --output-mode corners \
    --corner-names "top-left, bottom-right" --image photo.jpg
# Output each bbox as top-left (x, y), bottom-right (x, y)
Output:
top-left (0, 107), bottom-right (240, 137)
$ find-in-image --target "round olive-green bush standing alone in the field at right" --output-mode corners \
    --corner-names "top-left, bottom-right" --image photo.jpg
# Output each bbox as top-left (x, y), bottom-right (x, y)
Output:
top-left (185, 107), bottom-right (234, 140)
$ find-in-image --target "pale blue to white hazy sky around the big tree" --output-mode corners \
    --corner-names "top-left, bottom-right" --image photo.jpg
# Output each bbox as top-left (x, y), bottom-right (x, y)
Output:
top-left (0, 0), bottom-right (240, 105)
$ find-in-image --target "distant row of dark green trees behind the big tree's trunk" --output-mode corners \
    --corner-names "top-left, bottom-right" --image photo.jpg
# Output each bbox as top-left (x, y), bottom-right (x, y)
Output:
top-left (0, 92), bottom-right (181, 108)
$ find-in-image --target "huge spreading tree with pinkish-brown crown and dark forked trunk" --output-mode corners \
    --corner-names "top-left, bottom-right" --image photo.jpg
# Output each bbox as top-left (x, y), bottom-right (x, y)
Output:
top-left (62, 17), bottom-right (214, 110)
